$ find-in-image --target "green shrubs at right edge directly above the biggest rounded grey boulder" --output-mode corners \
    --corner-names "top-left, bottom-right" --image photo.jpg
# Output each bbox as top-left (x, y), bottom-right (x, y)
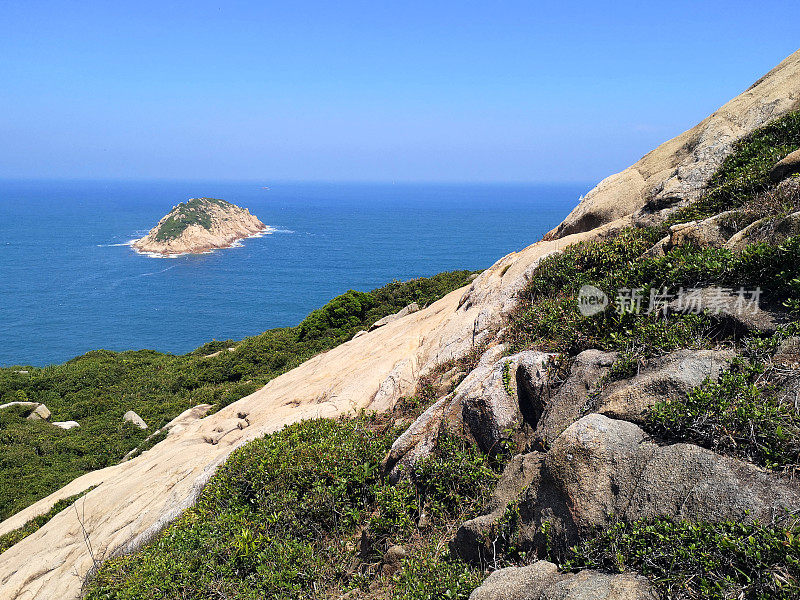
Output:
top-left (646, 362), bottom-right (800, 471)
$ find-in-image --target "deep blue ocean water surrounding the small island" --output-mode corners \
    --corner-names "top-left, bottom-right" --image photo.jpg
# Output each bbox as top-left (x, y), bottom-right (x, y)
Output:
top-left (0, 181), bottom-right (588, 366)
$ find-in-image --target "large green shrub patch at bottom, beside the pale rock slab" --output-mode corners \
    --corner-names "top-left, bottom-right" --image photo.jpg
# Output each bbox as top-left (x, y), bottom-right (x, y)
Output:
top-left (88, 417), bottom-right (390, 600)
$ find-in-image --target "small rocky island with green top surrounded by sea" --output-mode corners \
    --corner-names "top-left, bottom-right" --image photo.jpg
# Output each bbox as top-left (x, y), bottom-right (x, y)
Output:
top-left (131, 198), bottom-right (267, 255)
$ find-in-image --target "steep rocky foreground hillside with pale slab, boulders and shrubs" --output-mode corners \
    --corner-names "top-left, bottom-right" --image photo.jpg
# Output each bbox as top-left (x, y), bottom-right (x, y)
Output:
top-left (0, 52), bottom-right (800, 600)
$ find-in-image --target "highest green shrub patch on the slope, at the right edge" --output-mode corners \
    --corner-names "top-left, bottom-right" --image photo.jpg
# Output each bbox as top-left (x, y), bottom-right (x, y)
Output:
top-left (670, 112), bottom-right (800, 223)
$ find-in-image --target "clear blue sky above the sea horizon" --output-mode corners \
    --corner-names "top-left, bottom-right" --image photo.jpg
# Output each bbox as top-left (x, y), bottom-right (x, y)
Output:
top-left (0, 0), bottom-right (800, 183)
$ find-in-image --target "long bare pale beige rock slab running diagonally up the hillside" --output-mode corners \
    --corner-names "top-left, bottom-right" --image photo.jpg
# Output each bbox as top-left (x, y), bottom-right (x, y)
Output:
top-left (0, 52), bottom-right (800, 600)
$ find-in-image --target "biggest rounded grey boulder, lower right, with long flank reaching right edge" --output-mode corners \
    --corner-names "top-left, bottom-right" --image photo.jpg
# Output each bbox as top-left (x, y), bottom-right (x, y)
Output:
top-left (545, 414), bottom-right (800, 533)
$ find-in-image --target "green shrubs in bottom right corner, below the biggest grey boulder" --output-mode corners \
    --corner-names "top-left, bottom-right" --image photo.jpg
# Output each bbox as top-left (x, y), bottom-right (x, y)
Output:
top-left (561, 519), bottom-right (800, 600)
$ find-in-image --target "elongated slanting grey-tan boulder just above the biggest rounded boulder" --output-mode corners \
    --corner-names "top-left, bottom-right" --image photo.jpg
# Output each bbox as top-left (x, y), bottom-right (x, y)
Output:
top-left (594, 350), bottom-right (736, 422)
